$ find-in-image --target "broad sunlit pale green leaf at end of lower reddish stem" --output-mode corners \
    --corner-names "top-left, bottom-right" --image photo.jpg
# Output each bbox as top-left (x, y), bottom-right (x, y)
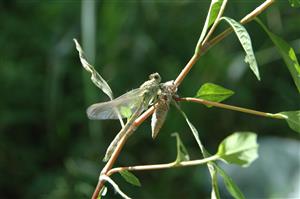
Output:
top-left (217, 132), bottom-right (258, 167)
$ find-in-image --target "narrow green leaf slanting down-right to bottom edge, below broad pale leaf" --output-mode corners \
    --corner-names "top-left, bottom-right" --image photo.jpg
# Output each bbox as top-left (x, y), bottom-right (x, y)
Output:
top-left (214, 164), bottom-right (245, 199)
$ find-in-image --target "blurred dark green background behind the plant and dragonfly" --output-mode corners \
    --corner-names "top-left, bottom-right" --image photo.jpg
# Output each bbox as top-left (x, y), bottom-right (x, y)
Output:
top-left (0, 0), bottom-right (300, 199)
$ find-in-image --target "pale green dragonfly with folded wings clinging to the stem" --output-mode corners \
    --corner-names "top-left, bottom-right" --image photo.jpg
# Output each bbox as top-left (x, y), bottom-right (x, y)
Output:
top-left (87, 73), bottom-right (161, 161)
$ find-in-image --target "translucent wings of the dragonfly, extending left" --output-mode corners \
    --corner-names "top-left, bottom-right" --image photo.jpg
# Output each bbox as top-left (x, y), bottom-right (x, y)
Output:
top-left (86, 88), bottom-right (143, 120)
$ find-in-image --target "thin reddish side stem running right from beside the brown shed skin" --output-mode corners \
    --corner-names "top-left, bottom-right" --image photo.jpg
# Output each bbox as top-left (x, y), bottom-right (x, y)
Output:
top-left (175, 97), bottom-right (285, 119)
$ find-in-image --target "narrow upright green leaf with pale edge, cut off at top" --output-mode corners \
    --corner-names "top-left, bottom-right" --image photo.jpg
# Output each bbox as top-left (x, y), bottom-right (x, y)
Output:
top-left (198, 0), bottom-right (223, 43)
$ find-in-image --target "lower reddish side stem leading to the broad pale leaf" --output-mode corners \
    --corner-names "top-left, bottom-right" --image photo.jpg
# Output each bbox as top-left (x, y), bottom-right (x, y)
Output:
top-left (107, 155), bottom-right (219, 176)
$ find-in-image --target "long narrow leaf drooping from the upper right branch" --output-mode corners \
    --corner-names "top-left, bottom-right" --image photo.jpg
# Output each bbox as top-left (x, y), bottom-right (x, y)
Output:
top-left (221, 17), bottom-right (260, 80)
